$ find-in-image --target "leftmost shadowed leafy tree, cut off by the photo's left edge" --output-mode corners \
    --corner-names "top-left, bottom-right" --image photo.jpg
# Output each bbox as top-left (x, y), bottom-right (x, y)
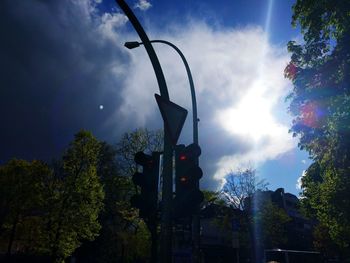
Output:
top-left (0, 159), bottom-right (51, 255)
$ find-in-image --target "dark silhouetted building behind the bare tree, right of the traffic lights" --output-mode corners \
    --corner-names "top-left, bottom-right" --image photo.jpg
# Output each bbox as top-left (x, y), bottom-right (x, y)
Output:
top-left (174, 188), bottom-right (314, 263)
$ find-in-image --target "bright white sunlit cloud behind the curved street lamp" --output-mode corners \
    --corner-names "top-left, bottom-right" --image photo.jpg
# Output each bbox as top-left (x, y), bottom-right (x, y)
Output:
top-left (121, 21), bottom-right (295, 188)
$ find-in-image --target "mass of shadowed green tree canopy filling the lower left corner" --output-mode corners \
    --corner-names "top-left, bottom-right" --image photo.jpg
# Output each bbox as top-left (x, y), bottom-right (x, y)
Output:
top-left (0, 130), bottom-right (104, 262)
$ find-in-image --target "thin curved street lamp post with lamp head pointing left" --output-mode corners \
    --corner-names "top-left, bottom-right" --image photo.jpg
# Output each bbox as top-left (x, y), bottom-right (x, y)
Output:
top-left (124, 40), bottom-right (200, 263)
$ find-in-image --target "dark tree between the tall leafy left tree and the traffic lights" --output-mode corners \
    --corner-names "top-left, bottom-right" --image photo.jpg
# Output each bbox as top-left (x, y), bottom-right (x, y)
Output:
top-left (74, 142), bottom-right (149, 262)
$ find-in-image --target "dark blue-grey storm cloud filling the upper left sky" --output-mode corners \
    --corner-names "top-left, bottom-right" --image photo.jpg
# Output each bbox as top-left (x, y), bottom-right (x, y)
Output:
top-left (0, 0), bottom-right (127, 162)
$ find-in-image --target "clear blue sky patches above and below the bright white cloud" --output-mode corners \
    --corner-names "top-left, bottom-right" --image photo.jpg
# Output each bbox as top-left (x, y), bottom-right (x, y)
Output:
top-left (107, 0), bottom-right (310, 194)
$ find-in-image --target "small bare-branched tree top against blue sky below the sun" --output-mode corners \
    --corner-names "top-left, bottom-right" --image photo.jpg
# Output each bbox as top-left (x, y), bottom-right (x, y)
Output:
top-left (221, 168), bottom-right (268, 210)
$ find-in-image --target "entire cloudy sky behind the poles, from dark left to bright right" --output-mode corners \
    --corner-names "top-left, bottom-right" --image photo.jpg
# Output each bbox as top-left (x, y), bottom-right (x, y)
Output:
top-left (0, 0), bottom-right (311, 194)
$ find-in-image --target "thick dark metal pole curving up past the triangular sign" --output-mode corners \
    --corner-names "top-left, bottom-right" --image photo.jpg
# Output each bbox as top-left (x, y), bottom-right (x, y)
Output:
top-left (116, 0), bottom-right (173, 263)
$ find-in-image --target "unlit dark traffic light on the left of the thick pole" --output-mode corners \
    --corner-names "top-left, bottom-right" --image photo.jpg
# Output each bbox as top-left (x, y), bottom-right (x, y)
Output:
top-left (130, 152), bottom-right (160, 220)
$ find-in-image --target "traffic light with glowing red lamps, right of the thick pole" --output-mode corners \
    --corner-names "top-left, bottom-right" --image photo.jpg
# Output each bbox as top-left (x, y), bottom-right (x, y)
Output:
top-left (174, 143), bottom-right (203, 217)
